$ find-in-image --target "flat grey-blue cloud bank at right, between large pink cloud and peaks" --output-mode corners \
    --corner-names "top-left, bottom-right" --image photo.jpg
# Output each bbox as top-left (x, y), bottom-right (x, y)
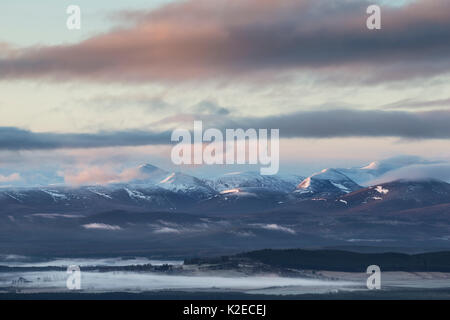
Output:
top-left (234, 110), bottom-right (450, 139)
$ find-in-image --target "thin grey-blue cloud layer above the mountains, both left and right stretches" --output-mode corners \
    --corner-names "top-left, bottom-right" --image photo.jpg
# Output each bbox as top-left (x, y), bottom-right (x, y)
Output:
top-left (0, 110), bottom-right (450, 150)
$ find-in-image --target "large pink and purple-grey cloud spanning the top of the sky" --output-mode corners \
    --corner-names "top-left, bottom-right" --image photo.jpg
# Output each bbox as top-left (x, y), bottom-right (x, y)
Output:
top-left (0, 0), bottom-right (450, 82)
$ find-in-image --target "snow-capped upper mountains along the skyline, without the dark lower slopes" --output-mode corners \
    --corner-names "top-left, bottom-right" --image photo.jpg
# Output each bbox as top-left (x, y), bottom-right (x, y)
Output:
top-left (0, 158), bottom-right (448, 214)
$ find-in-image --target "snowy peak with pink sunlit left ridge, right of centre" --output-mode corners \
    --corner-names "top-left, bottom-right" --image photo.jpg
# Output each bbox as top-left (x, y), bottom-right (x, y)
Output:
top-left (295, 169), bottom-right (361, 198)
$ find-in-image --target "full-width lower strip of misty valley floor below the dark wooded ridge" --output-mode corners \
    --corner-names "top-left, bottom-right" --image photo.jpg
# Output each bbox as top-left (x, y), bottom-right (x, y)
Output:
top-left (0, 271), bottom-right (450, 295)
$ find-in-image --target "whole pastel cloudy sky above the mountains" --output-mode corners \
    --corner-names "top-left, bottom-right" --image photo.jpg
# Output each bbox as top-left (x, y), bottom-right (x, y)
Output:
top-left (0, 0), bottom-right (450, 186)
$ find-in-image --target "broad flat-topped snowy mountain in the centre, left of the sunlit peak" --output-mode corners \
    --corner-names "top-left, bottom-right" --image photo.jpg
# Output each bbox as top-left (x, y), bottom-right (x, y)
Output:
top-left (208, 171), bottom-right (303, 192)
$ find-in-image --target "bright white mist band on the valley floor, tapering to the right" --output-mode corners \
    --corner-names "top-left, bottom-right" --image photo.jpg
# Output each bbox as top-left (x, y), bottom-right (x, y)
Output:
top-left (0, 271), bottom-right (360, 293)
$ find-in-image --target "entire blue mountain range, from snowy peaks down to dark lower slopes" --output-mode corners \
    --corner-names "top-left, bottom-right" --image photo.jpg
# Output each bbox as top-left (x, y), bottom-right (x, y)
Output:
top-left (0, 156), bottom-right (450, 255)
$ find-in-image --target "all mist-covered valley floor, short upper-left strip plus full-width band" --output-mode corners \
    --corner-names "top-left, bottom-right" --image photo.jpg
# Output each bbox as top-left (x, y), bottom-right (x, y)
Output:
top-left (0, 256), bottom-right (450, 295)
